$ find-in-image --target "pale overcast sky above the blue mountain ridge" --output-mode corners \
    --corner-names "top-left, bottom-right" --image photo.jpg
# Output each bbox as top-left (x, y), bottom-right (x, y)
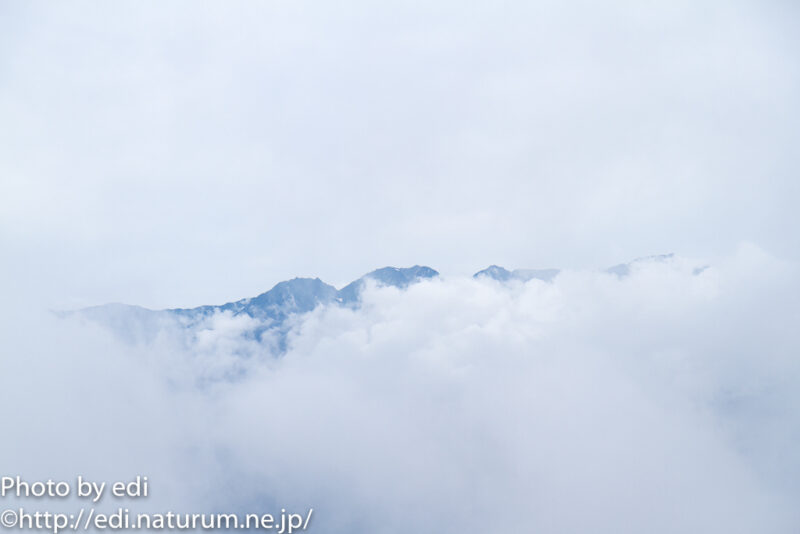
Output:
top-left (0, 0), bottom-right (800, 307)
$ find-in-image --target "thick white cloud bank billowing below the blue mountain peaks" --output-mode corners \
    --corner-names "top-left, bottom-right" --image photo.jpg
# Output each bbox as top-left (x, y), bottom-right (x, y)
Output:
top-left (0, 246), bottom-right (800, 533)
